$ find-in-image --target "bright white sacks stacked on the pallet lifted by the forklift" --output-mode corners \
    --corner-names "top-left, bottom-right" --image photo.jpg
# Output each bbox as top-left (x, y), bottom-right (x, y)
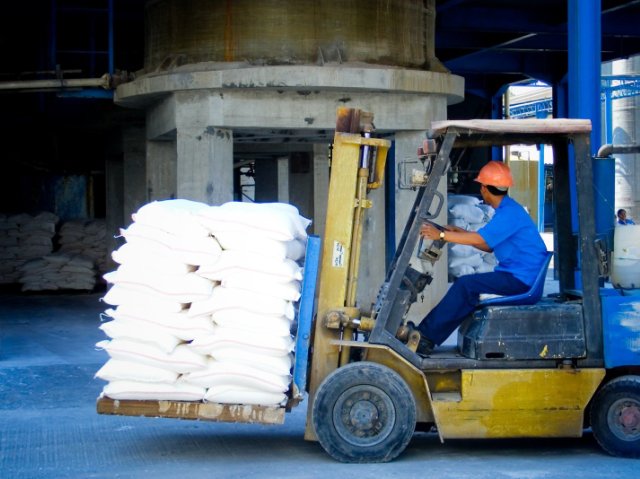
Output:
top-left (96, 200), bottom-right (310, 405)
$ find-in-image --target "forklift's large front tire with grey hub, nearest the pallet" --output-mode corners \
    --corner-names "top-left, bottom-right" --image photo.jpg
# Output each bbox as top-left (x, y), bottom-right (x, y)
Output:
top-left (312, 361), bottom-right (416, 463)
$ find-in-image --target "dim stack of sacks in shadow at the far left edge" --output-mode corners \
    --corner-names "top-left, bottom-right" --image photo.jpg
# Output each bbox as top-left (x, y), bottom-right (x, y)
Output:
top-left (0, 212), bottom-right (59, 284)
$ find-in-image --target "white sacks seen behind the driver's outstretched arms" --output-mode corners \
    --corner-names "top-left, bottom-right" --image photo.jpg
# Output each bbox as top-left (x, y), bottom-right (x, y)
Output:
top-left (447, 195), bottom-right (497, 278)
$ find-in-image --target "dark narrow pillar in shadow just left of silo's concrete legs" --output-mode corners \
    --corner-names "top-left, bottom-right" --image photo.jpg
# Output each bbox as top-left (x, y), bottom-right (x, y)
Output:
top-left (122, 125), bottom-right (147, 222)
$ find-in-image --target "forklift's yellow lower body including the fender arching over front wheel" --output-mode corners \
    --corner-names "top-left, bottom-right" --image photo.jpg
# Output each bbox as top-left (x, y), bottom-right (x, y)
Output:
top-left (331, 340), bottom-right (605, 440)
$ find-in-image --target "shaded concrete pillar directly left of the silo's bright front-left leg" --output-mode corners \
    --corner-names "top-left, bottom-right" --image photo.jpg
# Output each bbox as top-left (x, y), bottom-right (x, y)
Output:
top-left (145, 140), bottom-right (178, 202)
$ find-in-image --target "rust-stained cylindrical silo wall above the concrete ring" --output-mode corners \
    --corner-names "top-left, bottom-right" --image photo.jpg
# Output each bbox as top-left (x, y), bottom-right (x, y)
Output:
top-left (145, 0), bottom-right (435, 71)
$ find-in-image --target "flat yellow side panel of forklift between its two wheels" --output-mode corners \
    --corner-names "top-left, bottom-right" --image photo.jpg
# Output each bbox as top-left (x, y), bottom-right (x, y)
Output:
top-left (427, 368), bottom-right (605, 439)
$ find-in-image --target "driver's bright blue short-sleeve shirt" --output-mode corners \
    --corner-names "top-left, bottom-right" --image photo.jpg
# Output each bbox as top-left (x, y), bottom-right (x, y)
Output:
top-left (478, 196), bottom-right (547, 285)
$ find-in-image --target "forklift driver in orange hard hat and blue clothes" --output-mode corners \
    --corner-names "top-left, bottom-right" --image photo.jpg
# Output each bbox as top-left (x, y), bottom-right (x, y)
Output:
top-left (417, 161), bottom-right (547, 356)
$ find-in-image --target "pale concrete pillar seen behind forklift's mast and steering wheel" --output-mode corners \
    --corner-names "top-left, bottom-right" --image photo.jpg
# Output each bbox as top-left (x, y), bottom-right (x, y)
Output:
top-left (392, 131), bottom-right (449, 332)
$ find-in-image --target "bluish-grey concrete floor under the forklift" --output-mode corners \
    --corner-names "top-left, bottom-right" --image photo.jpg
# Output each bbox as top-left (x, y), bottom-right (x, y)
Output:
top-left (0, 293), bottom-right (640, 479)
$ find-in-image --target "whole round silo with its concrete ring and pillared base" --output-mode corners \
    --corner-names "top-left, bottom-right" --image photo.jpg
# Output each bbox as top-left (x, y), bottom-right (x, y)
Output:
top-left (115, 0), bottom-right (464, 312)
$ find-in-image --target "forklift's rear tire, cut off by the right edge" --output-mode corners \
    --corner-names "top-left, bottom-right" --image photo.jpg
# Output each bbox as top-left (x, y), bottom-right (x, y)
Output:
top-left (591, 376), bottom-right (640, 457)
